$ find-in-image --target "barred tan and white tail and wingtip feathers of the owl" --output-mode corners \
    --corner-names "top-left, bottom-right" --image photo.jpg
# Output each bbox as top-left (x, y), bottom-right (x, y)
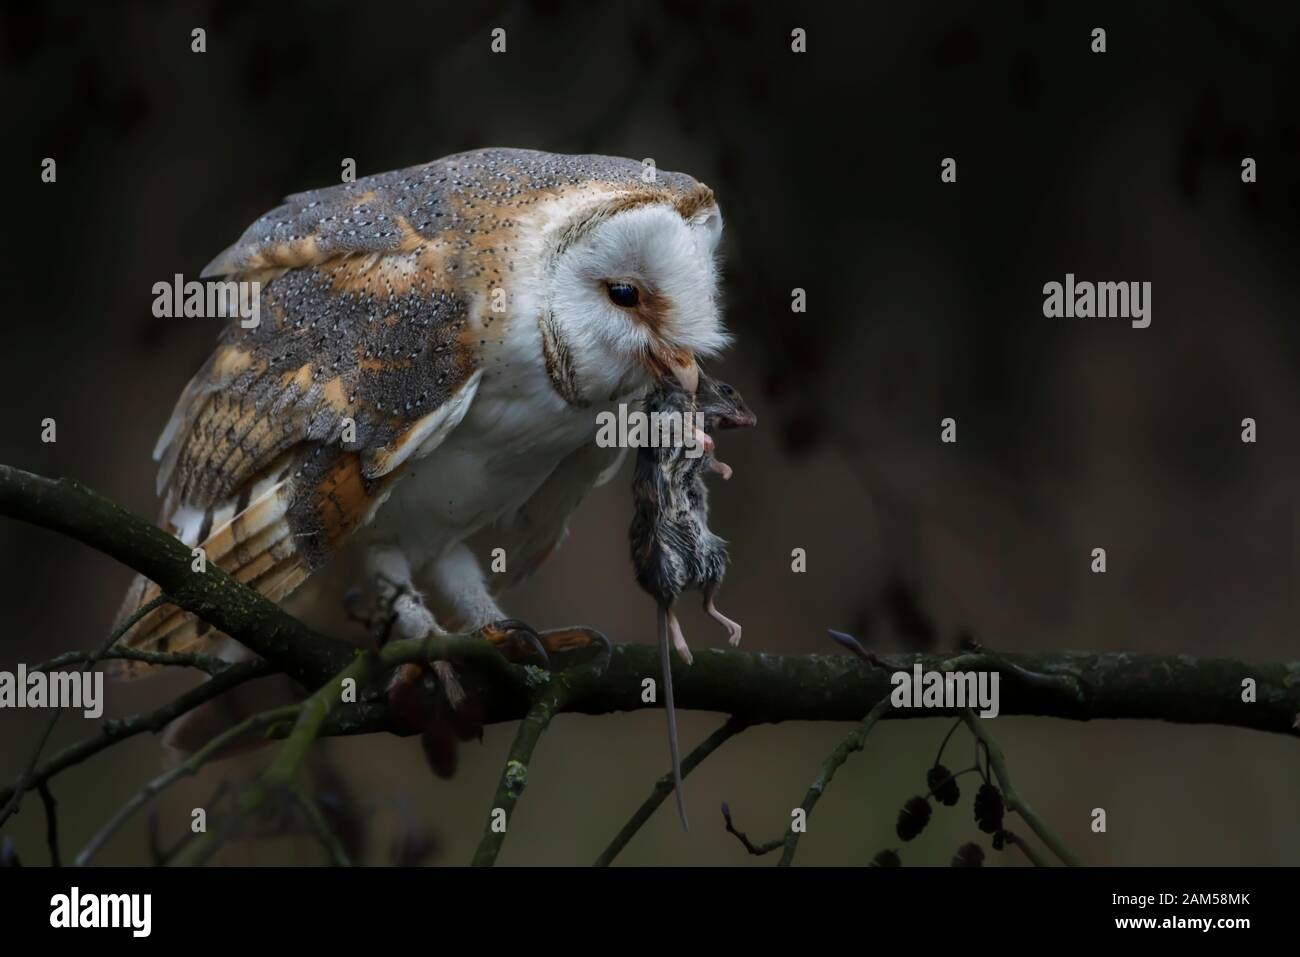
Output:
top-left (109, 479), bottom-right (308, 679)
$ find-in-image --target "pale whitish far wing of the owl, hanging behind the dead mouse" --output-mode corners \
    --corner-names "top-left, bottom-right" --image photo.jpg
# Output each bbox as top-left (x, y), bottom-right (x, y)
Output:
top-left (475, 442), bottom-right (627, 593)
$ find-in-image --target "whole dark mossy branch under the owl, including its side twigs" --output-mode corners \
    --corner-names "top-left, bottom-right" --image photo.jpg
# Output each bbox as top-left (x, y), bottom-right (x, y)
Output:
top-left (0, 465), bottom-right (1300, 863)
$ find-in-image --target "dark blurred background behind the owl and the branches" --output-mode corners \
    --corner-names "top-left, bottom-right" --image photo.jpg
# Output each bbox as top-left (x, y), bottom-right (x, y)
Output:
top-left (0, 0), bottom-right (1300, 865)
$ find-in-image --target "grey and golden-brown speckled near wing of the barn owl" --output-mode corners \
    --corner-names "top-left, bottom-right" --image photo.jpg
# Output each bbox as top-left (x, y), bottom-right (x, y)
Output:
top-left (111, 175), bottom-right (481, 671)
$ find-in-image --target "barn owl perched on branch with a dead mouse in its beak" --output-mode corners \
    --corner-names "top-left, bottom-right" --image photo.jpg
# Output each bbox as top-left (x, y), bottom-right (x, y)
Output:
top-left (115, 150), bottom-right (728, 671)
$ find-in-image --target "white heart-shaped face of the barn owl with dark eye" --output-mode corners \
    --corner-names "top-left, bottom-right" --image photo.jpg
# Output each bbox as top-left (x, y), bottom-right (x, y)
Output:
top-left (550, 204), bottom-right (728, 399)
